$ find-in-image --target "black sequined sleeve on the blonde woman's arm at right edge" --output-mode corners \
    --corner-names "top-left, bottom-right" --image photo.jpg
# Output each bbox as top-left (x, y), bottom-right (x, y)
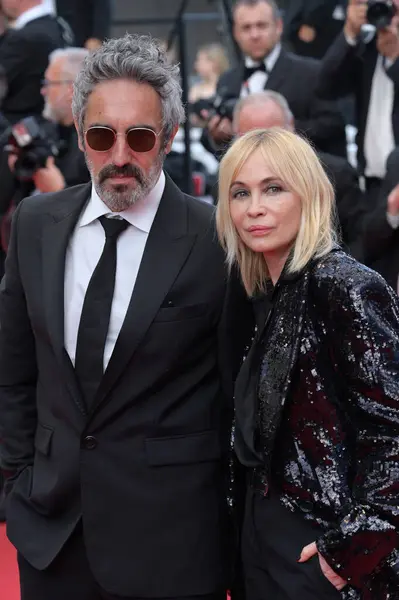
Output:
top-left (317, 272), bottom-right (399, 589)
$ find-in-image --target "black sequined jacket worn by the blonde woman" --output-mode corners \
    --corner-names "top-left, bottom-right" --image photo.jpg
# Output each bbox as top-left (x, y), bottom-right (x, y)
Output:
top-left (235, 249), bottom-right (399, 600)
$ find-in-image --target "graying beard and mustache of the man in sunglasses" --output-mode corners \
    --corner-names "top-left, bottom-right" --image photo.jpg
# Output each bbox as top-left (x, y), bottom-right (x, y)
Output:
top-left (85, 151), bottom-right (165, 212)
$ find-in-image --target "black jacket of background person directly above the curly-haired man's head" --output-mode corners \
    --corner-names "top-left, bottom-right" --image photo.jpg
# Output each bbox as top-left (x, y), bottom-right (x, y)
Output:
top-left (56, 0), bottom-right (113, 46)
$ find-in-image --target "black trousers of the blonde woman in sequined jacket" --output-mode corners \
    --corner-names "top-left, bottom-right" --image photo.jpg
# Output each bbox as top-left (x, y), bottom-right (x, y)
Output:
top-left (242, 490), bottom-right (342, 600)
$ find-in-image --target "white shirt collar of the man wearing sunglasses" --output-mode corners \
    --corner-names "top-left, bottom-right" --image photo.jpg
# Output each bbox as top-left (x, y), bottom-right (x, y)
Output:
top-left (78, 171), bottom-right (166, 233)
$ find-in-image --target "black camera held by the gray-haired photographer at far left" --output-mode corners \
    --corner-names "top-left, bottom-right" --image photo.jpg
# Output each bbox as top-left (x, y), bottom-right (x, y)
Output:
top-left (2, 117), bottom-right (60, 181)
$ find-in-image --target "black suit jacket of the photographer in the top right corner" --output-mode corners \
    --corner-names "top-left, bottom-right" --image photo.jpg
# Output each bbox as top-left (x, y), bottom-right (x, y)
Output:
top-left (317, 33), bottom-right (399, 170)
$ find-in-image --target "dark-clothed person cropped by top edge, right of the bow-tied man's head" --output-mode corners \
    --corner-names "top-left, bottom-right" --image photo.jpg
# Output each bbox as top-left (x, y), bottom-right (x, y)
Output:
top-left (284, 0), bottom-right (347, 58)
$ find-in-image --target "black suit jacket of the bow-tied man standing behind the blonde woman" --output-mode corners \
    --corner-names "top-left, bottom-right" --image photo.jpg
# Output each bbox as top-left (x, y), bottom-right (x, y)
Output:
top-left (217, 49), bottom-right (346, 156)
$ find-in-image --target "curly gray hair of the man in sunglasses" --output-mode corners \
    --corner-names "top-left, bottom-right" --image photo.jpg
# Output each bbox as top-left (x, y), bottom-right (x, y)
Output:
top-left (72, 34), bottom-right (185, 143)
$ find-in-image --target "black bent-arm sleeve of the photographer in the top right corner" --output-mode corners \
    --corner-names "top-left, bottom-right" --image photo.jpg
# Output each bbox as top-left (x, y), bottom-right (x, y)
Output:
top-left (316, 33), bottom-right (362, 100)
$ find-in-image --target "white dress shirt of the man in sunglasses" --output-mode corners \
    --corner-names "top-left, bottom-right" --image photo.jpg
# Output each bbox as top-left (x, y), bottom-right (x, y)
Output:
top-left (64, 172), bottom-right (165, 371)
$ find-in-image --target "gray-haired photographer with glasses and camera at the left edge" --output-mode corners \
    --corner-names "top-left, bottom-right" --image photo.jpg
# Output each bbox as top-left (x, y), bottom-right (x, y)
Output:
top-left (0, 48), bottom-right (90, 251)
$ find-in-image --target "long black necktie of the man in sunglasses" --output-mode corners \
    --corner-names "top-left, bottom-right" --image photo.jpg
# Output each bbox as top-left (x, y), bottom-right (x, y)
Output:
top-left (75, 217), bottom-right (129, 409)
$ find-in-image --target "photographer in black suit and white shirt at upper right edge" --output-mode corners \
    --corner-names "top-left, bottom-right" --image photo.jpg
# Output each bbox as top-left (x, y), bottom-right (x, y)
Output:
top-left (318, 0), bottom-right (399, 208)
